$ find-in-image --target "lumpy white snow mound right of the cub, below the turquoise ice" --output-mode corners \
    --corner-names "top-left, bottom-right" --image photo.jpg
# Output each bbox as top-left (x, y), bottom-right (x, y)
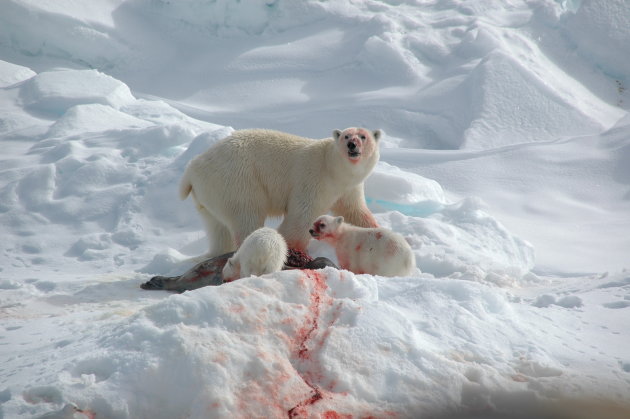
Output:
top-left (377, 199), bottom-right (535, 286)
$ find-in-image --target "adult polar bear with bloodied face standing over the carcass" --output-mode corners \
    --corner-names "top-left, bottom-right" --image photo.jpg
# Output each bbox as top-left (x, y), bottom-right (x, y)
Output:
top-left (180, 128), bottom-right (381, 257)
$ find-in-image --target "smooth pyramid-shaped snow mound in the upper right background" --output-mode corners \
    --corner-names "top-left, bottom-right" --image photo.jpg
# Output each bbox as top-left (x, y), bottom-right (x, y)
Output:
top-left (461, 52), bottom-right (623, 149)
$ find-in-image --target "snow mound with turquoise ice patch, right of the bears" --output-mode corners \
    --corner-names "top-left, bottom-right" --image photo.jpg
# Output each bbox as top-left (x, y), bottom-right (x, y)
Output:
top-left (362, 162), bottom-right (535, 278)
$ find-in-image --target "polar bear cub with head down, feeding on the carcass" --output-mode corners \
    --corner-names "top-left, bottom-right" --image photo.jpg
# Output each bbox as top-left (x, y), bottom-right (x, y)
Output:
top-left (223, 227), bottom-right (288, 282)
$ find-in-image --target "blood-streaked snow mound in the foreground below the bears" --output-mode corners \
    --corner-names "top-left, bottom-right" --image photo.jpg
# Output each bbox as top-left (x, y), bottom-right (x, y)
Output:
top-left (0, 268), bottom-right (561, 419)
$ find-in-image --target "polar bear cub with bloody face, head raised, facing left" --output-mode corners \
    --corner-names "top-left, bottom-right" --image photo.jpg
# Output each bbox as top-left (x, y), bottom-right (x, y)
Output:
top-left (309, 215), bottom-right (416, 276)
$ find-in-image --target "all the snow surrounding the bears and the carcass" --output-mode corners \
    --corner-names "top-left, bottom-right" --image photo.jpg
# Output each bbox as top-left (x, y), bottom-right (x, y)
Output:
top-left (0, 0), bottom-right (630, 419)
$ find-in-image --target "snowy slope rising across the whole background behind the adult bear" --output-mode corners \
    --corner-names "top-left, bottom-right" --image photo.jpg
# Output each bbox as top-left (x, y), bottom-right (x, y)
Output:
top-left (0, 0), bottom-right (630, 149)
